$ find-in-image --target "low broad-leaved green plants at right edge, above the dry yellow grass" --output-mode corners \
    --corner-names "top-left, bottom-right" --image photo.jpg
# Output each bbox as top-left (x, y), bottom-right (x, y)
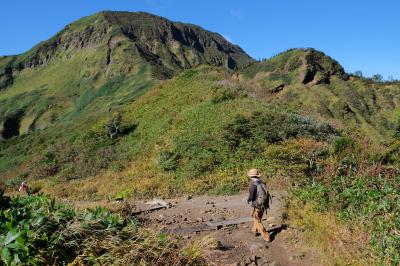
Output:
top-left (294, 175), bottom-right (400, 265)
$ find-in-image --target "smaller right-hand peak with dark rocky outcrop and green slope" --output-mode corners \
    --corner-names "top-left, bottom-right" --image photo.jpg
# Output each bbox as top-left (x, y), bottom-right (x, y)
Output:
top-left (239, 49), bottom-right (400, 140)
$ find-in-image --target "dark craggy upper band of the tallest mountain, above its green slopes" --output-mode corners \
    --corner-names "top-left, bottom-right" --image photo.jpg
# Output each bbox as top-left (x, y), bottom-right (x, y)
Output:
top-left (0, 12), bottom-right (252, 90)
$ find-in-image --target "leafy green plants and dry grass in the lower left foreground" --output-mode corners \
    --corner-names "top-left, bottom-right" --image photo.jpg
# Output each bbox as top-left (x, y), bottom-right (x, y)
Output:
top-left (0, 191), bottom-right (201, 265)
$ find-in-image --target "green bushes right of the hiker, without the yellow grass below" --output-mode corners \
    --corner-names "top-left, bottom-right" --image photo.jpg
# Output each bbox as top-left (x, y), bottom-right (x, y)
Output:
top-left (284, 137), bottom-right (400, 265)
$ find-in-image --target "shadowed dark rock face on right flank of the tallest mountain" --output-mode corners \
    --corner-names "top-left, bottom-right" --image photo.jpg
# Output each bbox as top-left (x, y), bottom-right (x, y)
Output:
top-left (103, 12), bottom-right (252, 69)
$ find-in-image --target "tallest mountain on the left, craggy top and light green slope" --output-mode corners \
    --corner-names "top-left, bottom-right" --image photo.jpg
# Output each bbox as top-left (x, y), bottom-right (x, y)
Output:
top-left (0, 12), bottom-right (253, 138)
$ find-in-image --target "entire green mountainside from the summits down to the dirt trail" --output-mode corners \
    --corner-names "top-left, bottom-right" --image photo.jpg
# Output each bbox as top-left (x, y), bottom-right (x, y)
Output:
top-left (0, 12), bottom-right (400, 265)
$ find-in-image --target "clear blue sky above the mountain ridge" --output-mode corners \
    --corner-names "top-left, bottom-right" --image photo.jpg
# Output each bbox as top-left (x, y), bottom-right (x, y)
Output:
top-left (0, 0), bottom-right (400, 79)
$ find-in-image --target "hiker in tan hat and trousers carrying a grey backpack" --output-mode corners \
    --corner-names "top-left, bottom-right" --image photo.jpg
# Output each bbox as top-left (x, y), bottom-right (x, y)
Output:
top-left (247, 169), bottom-right (271, 242)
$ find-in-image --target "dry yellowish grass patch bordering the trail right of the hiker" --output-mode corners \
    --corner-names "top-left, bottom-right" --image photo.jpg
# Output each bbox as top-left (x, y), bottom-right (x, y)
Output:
top-left (287, 199), bottom-right (377, 265)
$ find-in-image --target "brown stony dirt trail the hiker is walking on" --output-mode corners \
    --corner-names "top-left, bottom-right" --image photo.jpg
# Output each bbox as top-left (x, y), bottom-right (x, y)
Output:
top-left (131, 191), bottom-right (321, 266)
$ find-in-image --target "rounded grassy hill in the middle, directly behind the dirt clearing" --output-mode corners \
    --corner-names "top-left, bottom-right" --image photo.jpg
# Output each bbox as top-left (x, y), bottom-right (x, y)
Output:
top-left (7, 67), bottom-right (336, 198)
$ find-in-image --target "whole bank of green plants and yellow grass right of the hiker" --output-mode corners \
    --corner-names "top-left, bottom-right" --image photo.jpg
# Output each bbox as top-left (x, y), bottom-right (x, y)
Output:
top-left (289, 137), bottom-right (400, 265)
